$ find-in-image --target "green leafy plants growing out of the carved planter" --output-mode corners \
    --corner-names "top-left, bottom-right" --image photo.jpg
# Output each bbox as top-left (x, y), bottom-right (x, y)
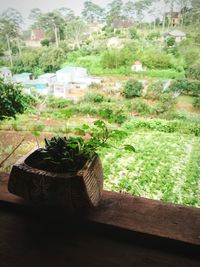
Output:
top-left (41, 120), bottom-right (134, 172)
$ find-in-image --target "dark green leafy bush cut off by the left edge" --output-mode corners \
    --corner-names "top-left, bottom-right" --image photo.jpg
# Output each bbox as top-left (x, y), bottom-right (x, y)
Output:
top-left (0, 79), bottom-right (31, 120)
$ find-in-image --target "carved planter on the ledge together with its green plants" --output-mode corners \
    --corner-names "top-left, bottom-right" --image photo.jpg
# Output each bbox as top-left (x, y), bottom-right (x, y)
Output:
top-left (8, 120), bottom-right (135, 211)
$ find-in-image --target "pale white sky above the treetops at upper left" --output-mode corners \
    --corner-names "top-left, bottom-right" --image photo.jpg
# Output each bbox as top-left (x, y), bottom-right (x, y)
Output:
top-left (0, 0), bottom-right (112, 28)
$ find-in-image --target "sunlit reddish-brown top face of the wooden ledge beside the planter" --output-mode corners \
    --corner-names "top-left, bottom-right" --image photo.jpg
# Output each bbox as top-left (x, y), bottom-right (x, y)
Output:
top-left (0, 174), bottom-right (200, 245)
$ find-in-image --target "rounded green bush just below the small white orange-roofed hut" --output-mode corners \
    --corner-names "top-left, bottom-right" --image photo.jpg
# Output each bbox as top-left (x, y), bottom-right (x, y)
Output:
top-left (123, 80), bottom-right (143, 98)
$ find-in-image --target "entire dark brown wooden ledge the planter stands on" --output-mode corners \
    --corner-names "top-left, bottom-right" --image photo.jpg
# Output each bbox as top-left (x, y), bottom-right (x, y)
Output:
top-left (0, 174), bottom-right (200, 267)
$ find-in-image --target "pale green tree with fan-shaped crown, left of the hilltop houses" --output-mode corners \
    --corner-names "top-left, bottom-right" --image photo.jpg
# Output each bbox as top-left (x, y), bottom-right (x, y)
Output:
top-left (66, 17), bottom-right (86, 48)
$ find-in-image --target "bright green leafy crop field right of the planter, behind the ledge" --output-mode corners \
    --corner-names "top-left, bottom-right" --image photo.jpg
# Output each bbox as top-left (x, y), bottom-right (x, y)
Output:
top-left (100, 127), bottom-right (200, 207)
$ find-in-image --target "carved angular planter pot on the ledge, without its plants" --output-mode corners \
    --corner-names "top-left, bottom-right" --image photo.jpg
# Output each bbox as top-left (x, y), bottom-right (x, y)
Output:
top-left (8, 149), bottom-right (103, 211)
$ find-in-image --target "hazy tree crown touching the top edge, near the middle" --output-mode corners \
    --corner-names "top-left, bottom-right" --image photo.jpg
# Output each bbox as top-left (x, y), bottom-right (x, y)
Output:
top-left (82, 0), bottom-right (104, 23)
